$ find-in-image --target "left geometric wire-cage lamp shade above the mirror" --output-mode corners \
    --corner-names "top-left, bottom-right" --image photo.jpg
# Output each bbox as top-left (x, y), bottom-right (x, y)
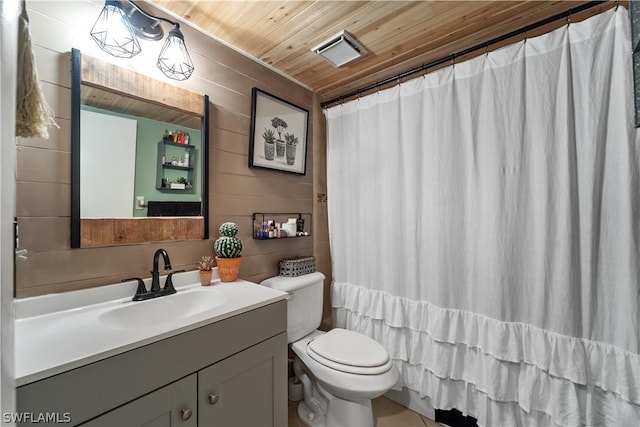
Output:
top-left (91, 0), bottom-right (141, 58)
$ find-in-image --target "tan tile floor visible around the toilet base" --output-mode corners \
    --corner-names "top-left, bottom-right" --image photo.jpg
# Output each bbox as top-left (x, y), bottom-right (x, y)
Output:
top-left (289, 396), bottom-right (442, 427)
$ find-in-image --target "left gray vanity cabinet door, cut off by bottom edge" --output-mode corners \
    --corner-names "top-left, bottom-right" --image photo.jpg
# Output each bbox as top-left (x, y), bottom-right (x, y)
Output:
top-left (82, 374), bottom-right (198, 427)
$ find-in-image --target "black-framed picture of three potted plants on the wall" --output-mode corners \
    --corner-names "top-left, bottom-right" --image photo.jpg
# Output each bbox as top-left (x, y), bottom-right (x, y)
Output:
top-left (249, 87), bottom-right (309, 175)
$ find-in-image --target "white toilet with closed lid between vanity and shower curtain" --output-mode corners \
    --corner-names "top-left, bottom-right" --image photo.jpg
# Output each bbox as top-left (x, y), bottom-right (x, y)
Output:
top-left (261, 272), bottom-right (398, 427)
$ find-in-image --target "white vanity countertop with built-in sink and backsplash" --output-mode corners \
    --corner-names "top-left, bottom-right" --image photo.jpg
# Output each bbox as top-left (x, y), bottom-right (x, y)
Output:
top-left (15, 271), bottom-right (287, 386)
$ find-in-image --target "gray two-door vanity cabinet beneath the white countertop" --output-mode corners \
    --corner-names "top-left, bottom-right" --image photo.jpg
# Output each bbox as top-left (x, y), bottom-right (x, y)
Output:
top-left (17, 300), bottom-right (287, 427)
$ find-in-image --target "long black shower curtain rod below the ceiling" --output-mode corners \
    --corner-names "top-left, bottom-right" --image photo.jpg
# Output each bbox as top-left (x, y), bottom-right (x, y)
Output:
top-left (320, 0), bottom-right (608, 108)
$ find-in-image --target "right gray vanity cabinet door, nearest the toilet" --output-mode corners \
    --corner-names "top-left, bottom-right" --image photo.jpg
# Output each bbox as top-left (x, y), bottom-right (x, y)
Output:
top-left (198, 333), bottom-right (287, 427)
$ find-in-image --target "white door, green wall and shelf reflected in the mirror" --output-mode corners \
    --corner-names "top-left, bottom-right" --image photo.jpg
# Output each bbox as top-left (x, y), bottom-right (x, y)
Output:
top-left (80, 103), bottom-right (202, 218)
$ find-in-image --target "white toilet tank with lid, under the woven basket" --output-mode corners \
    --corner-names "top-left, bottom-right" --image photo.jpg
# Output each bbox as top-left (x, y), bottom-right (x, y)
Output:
top-left (260, 272), bottom-right (324, 343)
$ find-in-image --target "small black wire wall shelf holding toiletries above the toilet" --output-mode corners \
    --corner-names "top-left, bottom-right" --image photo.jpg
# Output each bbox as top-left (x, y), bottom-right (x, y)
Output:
top-left (252, 212), bottom-right (312, 240)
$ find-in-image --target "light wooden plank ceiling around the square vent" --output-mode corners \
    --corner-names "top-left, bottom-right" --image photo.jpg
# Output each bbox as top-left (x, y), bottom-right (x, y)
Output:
top-left (154, 0), bottom-right (625, 100)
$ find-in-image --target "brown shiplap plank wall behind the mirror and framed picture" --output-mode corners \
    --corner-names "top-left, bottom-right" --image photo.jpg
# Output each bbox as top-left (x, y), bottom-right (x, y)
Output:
top-left (16, 0), bottom-right (331, 308)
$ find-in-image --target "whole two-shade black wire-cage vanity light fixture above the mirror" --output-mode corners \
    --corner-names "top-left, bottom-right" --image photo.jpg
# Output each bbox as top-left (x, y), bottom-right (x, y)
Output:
top-left (91, 0), bottom-right (195, 80)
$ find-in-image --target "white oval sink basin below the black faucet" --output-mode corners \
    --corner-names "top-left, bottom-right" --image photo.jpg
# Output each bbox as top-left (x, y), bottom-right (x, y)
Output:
top-left (98, 289), bottom-right (227, 329)
